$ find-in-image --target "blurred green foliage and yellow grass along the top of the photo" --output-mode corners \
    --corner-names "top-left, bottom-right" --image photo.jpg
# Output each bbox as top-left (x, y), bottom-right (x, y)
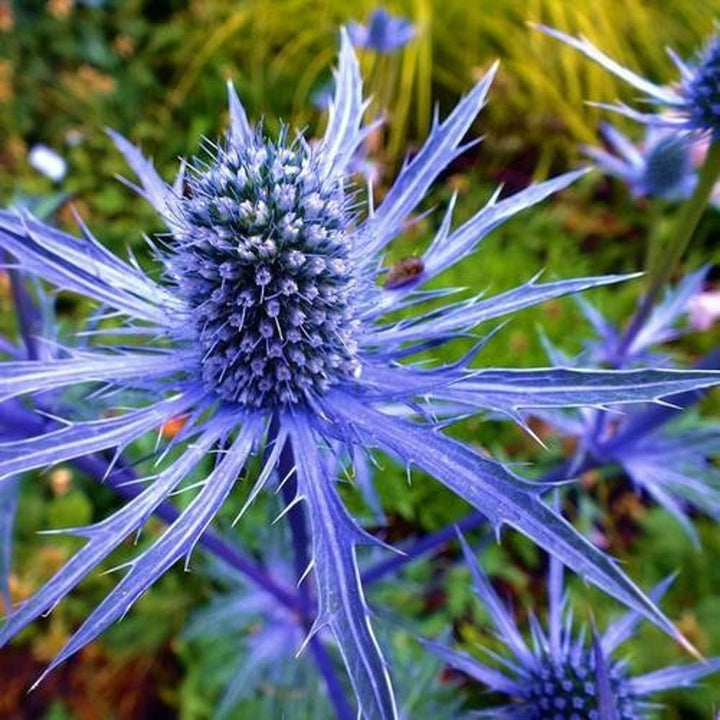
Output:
top-left (0, 0), bottom-right (720, 211)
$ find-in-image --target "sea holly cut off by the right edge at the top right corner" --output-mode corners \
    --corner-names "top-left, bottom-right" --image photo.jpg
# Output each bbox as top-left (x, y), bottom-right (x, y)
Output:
top-left (536, 25), bottom-right (720, 137)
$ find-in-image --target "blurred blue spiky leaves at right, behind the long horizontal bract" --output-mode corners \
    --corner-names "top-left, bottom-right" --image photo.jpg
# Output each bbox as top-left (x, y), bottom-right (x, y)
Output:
top-left (533, 267), bottom-right (720, 544)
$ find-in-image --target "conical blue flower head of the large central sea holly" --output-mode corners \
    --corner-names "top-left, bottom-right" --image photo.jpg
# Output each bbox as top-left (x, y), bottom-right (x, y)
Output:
top-left (174, 132), bottom-right (358, 407)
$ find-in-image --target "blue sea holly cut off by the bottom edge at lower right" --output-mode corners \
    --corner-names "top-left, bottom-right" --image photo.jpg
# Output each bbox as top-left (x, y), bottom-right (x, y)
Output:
top-left (423, 536), bottom-right (720, 720)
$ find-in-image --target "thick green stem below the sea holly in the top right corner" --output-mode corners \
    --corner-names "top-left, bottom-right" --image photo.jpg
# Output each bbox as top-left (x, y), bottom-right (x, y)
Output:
top-left (617, 140), bottom-right (720, 357)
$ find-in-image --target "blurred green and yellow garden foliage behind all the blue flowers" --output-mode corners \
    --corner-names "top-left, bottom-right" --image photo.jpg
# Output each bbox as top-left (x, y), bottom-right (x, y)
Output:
top-left (0, 0), bottom-right (720, 720)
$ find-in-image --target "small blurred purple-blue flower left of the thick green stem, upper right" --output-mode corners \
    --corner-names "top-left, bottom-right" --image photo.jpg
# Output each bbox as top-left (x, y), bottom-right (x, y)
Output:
top-left (585, 124), bottom-right (697, 200)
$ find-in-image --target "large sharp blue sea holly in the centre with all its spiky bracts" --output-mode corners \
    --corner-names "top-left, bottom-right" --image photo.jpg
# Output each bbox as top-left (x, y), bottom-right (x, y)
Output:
top-left (0, 32), bottom-right (718, 719)
